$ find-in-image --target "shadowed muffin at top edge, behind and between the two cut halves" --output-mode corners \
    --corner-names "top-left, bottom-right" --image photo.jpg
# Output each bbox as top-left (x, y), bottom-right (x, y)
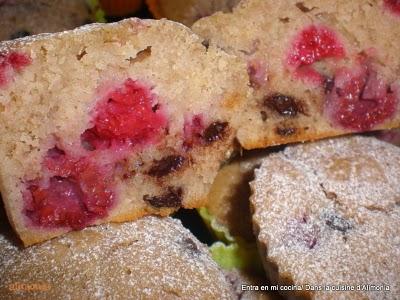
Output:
top-left (146, 0), bottom-right (240, 26)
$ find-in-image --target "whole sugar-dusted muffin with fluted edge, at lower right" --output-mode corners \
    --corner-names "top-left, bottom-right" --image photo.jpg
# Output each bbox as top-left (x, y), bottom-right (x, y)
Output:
top-left (251, 136), bottom-right (400, 299)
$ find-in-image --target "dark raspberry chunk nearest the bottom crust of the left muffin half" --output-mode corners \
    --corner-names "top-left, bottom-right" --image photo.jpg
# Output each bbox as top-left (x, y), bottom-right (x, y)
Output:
top-left (25, 147), bottom-right (115, 229)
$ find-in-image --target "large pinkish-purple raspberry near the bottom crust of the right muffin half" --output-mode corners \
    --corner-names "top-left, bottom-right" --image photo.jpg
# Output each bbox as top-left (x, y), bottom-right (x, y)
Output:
top-left (325, 63), bottom-right (398, 131)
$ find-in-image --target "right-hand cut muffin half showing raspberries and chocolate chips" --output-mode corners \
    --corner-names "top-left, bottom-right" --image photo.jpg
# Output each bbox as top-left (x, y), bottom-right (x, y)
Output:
top-left (192, 0), bottom-right (400, 149)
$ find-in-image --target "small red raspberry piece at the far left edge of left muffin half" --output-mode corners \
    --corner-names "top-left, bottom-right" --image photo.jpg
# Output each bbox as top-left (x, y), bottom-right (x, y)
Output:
top-left (0, 52), bottom-right (31, 88)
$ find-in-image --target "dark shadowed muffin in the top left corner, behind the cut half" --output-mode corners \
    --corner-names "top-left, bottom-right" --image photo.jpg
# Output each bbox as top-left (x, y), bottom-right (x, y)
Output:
top-left (0, 0), bottom-right (90, 40)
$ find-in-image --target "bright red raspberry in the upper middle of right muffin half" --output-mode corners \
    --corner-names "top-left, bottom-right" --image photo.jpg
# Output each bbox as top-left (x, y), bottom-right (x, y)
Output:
top-left (287, 25), bottom-right (345, 84)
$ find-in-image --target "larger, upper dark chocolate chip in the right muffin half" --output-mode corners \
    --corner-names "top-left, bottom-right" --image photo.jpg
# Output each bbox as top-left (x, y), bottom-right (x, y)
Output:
top-left (264, 94), bottom-right (303, 117)
